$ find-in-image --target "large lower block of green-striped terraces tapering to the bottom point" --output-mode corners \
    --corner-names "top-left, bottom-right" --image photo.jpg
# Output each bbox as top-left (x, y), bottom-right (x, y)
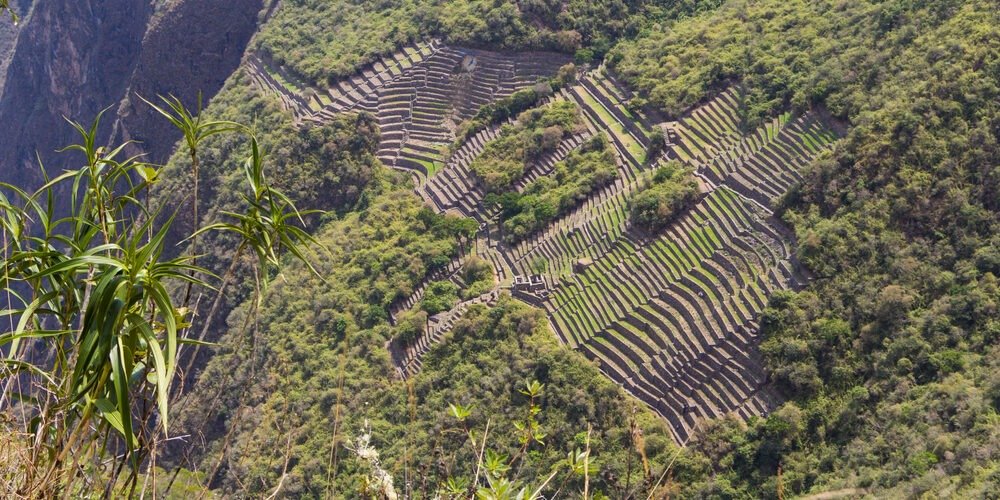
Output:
top-left (544, 188), bottom-right (802, 441)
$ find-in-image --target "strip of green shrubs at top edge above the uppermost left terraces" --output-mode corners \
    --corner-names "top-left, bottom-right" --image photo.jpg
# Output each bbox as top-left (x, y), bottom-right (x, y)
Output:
top-left (256, 0), bottom-right (719, 83)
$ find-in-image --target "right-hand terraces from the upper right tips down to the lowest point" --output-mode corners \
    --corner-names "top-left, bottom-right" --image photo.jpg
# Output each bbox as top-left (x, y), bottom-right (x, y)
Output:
top-left (508, 89), bottom-right (838, 442)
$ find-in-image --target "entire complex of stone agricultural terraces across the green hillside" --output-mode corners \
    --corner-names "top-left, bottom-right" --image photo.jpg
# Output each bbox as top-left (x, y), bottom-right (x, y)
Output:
top-left (249, 47), bottom-right (841, 442)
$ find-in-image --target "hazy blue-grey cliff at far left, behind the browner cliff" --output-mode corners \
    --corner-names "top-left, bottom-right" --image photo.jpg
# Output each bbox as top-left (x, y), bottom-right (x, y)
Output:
top-left (0, 0), bottom-right (150, 189)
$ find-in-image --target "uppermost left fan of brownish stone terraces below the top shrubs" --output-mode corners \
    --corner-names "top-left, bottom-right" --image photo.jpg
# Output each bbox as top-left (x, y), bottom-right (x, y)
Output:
top-left (247, 41), bottom-right (569, 184)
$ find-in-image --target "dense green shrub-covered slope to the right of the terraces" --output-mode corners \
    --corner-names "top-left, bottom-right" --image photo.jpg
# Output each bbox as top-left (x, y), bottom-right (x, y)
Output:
top-left (612, 1), bottom-right (1000, 497)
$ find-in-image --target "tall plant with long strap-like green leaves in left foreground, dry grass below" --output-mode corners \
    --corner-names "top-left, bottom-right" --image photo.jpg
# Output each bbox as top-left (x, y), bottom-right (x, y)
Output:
top-left (0, 100), bottom-right (311, 497)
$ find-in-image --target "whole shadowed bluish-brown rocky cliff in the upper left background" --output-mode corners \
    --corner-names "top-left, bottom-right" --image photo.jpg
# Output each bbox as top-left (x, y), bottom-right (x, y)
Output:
top-left (0, 0), bottom-right (261, 191)
